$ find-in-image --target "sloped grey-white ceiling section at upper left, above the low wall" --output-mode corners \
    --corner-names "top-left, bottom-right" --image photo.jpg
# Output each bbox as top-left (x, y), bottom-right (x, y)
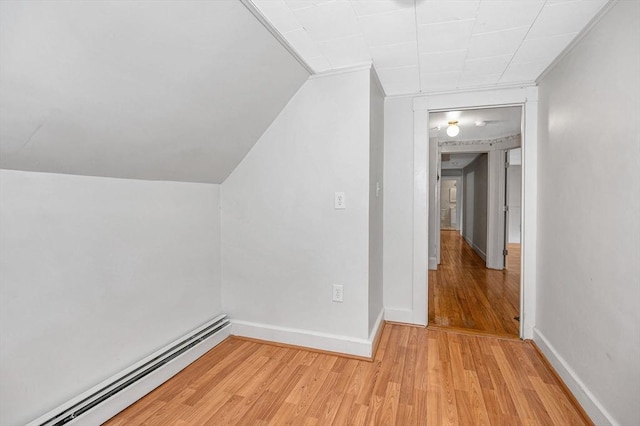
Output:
top-left (0, 0), bottom-right (309, 183)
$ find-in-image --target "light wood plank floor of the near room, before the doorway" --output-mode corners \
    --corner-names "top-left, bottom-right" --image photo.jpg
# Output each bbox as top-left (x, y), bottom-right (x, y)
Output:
top-left (106, 324), bottom-right (590, 426)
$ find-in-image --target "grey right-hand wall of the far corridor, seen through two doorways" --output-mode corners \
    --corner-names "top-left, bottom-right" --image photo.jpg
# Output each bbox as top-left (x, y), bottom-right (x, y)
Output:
top-left (462, 154), bottom-right (489, 260)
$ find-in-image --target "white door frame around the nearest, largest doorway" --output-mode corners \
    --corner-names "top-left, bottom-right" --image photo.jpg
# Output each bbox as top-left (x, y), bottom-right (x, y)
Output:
top-left (412, 85), bottom-right (538, 339)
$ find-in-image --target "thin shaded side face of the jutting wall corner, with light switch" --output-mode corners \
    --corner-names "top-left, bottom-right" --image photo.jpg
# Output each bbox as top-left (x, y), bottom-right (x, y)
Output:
top-left (369, 68), bottom-right (384, 334)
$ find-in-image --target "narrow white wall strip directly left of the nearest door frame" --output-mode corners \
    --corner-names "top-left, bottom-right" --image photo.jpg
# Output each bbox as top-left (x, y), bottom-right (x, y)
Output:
top-left (383, 98), bottom-right (413, 322)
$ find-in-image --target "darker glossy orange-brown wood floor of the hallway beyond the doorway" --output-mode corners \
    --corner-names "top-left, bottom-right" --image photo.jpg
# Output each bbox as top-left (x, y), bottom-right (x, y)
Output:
top-left (429, 231), bottom-right (520, 337)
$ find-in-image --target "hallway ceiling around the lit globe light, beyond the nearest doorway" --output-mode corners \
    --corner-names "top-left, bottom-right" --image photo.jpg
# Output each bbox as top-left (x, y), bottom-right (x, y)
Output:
top-left (429, 106), bottom-right (522, 141)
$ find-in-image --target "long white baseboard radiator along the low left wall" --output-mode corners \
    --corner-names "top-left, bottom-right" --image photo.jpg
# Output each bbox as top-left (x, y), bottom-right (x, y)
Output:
top-left (27, 315), bottom-right (231, 426)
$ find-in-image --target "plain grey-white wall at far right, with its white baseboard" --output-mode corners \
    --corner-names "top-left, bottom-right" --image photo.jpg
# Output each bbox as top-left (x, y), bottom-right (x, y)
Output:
top-left (536, 1), bottom-right (640, 425)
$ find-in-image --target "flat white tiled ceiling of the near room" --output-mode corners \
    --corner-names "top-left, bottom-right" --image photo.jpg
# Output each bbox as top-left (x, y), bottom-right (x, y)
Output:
top-left (248, 0), bottom-right (607, 95)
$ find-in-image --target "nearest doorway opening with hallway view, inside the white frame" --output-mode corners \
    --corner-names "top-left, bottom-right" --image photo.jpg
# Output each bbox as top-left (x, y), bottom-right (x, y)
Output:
top-left (428, 105), bottom-right (523, 337)
